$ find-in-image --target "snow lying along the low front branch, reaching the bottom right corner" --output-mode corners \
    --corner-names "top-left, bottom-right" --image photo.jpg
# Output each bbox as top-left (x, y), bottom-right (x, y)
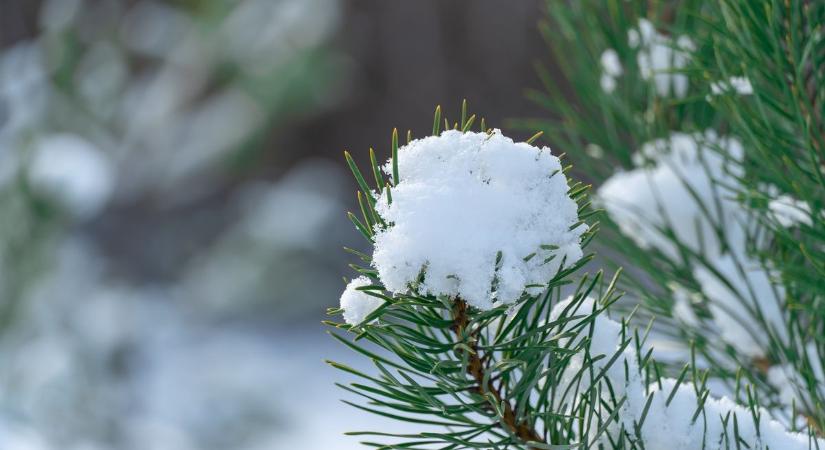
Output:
top-left (551, 297), bottom-right (825, 450)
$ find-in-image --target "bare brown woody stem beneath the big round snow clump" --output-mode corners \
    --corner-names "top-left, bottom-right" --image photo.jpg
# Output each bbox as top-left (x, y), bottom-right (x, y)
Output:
top-left (453, 298), bottom-right (546, 450)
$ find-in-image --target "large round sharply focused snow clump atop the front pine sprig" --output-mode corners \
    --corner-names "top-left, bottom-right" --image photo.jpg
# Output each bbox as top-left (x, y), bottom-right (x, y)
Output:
top-left (373, 130), bottom-right (586, 309)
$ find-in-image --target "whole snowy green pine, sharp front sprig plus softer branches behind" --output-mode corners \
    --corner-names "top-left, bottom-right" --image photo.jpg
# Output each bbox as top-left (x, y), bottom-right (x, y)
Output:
top-left (328, 0), bottom-right (825, 449)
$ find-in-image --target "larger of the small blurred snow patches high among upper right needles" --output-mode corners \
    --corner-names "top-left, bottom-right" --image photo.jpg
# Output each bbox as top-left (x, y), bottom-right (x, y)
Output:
top-left (627, 19), bottom-right (695, 98)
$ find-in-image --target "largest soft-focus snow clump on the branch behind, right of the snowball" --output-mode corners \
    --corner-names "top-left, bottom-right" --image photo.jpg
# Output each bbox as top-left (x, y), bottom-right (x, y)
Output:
top-left (598, 132), bottom-right (743, 260)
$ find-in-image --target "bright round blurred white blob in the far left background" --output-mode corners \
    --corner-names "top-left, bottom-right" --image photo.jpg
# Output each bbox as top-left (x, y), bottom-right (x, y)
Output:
top-left (29, 134), bottom-right (115, 218)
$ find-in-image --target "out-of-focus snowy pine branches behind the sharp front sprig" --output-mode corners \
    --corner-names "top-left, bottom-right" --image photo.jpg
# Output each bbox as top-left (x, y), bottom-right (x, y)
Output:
top-left (524, 0), bottom-right (825, 436)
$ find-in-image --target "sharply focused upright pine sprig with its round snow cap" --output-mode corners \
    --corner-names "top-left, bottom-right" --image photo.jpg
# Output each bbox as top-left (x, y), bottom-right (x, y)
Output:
top-left (334, 110), bottom-right (600, 448)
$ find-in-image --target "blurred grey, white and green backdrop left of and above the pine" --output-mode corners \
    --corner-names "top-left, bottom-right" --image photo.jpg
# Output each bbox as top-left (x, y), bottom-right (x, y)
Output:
top-left (0, 0), bottom-right (552, 450)
